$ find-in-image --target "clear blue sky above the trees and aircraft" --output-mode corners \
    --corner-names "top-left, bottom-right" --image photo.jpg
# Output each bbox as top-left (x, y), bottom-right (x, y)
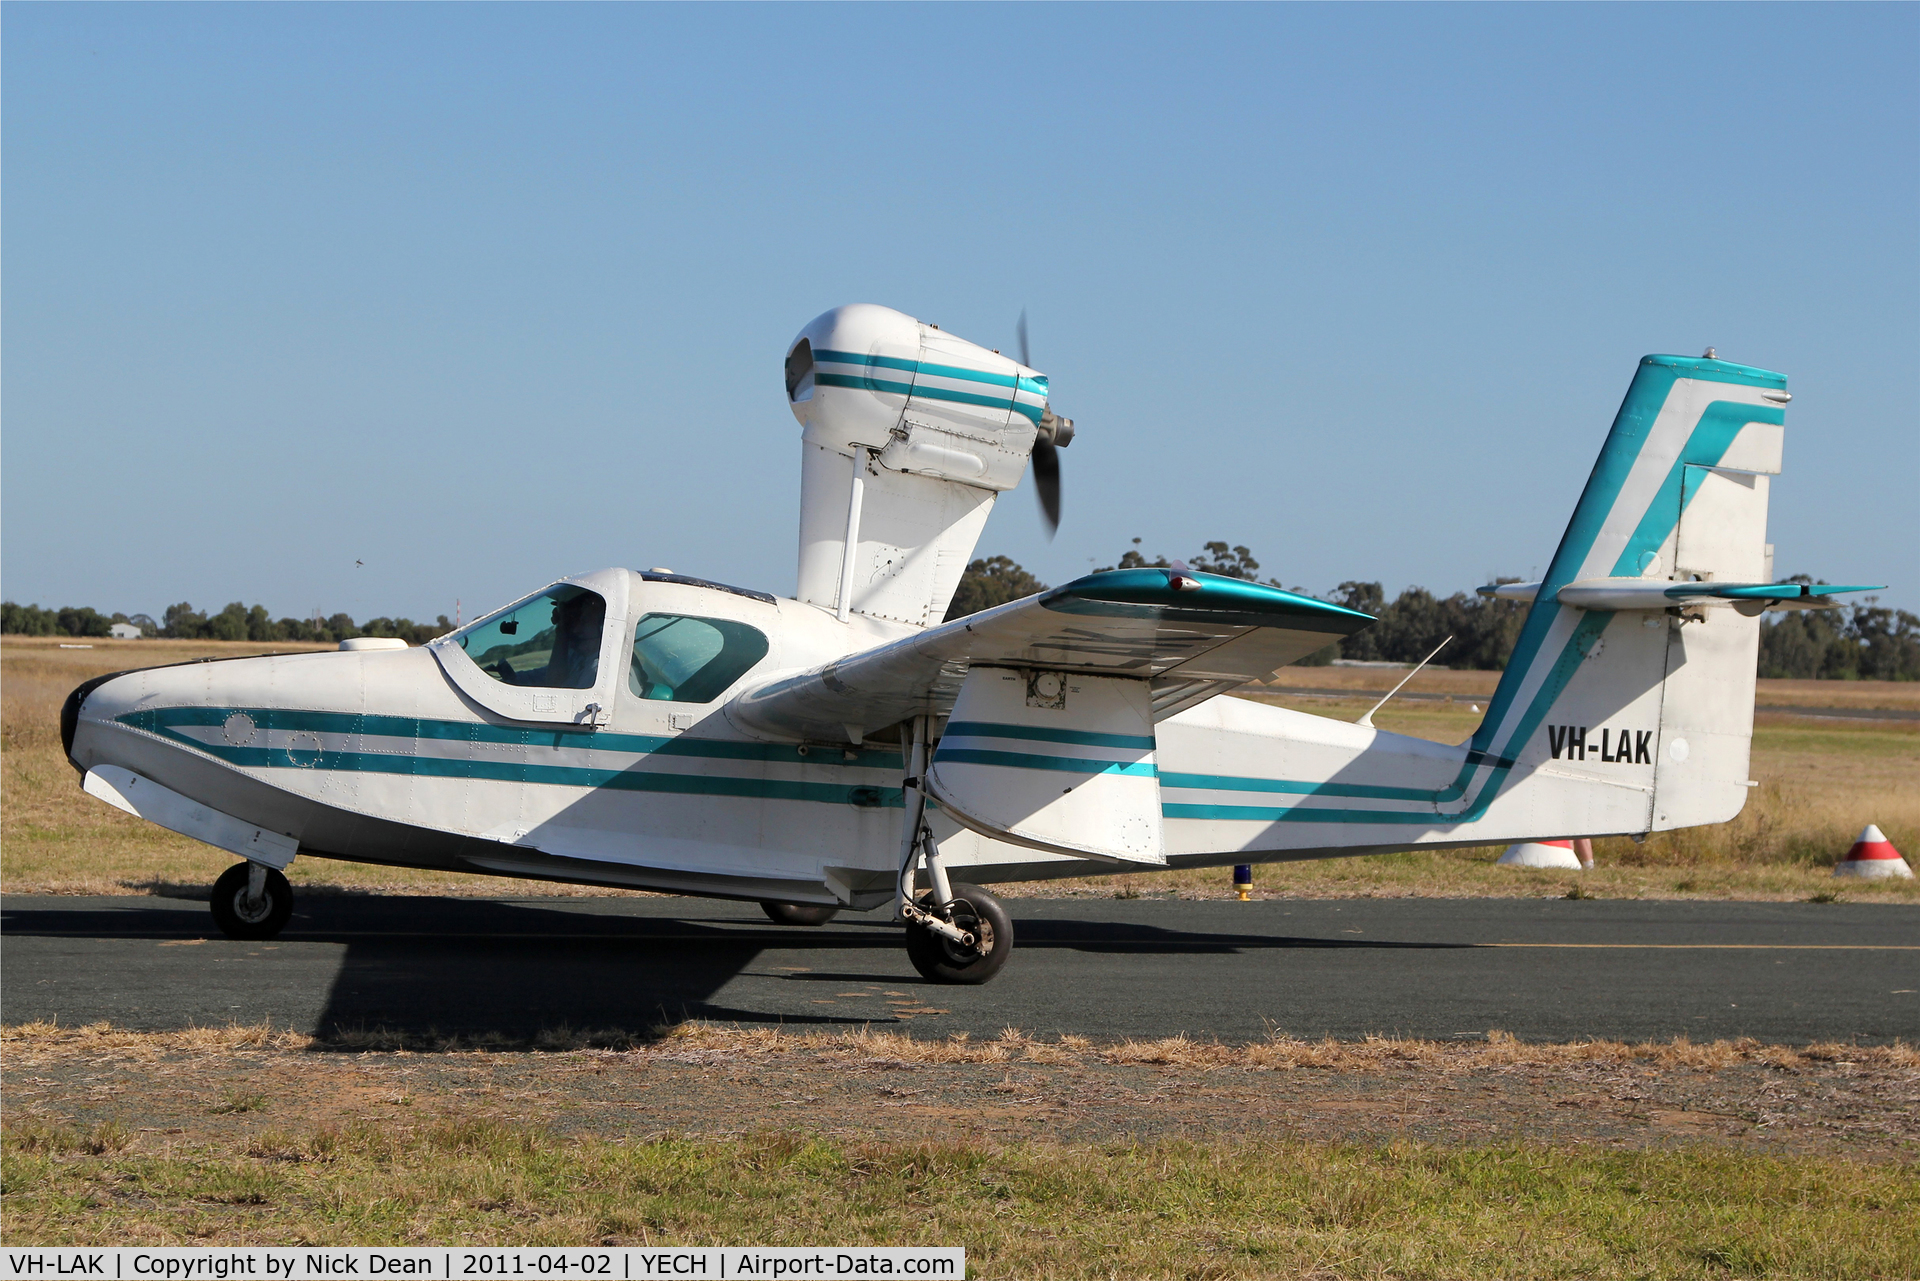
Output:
top-left (0, 4), bottom-right (1920, 618)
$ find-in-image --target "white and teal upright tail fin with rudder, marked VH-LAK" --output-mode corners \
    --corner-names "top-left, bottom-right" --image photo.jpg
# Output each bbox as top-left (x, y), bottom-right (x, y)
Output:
top-left (1471, 355), bottom-right (1788, 832)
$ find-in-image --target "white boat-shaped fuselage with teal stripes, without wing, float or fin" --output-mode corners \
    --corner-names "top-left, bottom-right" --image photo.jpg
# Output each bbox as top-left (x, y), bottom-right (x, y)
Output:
top-left (71, 570), bottom-right (1712, 908)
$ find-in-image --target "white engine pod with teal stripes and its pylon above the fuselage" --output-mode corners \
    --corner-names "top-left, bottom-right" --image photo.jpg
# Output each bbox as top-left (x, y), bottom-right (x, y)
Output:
top-left (785, 303), bottom-right (1071, 626)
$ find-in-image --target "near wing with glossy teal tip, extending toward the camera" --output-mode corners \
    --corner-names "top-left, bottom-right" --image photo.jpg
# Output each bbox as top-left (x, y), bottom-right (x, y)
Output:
top-left (728, 568), bottom-right (1373, 741)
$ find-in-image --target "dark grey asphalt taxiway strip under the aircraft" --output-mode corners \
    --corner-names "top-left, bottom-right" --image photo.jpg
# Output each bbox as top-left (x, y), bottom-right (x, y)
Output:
top-left (0, 895), bottom-right (1920, 1043)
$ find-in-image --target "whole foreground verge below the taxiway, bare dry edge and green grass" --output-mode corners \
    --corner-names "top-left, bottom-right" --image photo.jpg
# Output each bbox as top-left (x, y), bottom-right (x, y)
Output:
top-left (0, 1024), bottom-right (1920, 1279)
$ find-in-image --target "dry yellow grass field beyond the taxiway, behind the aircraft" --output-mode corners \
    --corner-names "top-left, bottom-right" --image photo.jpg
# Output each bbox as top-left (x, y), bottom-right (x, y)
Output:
top-left (0, 636), bottom-right (1920, 903)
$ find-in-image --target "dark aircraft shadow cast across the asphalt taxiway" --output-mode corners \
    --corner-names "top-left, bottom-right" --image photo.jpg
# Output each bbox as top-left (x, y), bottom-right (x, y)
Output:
top-left (4, 895), bottom-right (1463, 1041)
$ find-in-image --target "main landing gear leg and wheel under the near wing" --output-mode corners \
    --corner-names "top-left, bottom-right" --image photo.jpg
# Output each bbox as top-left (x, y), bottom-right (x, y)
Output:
top-left (893, 716), bottom-right (1014, 983)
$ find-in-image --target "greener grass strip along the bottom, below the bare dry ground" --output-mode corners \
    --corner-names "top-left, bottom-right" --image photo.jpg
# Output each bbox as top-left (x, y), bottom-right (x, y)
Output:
top-left (0, 1116), bottom-right (1920, 1277)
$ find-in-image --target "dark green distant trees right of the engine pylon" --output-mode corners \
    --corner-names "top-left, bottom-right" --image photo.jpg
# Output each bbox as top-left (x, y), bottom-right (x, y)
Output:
top-left (947, 538), bottom-right (1920, 680)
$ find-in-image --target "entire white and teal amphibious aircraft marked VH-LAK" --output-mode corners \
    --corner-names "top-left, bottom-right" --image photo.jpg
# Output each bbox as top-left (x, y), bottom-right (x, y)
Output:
top-left (61, 305), bottom-right (1866, 983)
